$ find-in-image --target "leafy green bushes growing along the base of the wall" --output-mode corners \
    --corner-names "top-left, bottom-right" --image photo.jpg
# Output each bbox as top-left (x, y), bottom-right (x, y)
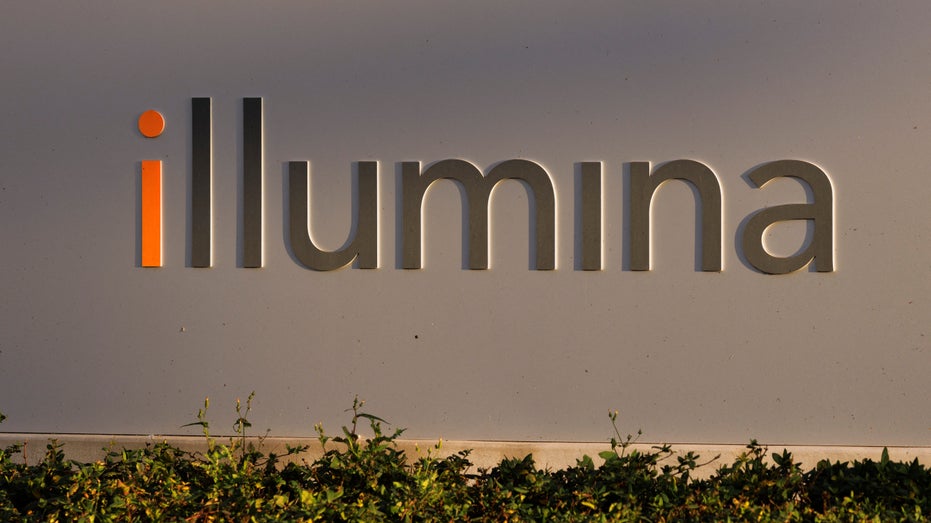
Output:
top-left (0, 402), bottom-right (931, 522)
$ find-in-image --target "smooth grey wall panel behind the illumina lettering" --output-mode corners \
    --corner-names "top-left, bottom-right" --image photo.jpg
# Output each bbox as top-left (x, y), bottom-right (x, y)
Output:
top-left (0, 0), bottom-right (931, 446)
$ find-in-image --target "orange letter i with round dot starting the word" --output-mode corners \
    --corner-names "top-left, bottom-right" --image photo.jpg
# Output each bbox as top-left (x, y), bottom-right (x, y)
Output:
top-left (139, 110), bottom-right (165, 267)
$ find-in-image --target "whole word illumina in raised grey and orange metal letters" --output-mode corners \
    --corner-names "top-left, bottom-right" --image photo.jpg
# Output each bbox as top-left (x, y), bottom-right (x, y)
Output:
top-left (138, 98), bottom-right (834, 274)
